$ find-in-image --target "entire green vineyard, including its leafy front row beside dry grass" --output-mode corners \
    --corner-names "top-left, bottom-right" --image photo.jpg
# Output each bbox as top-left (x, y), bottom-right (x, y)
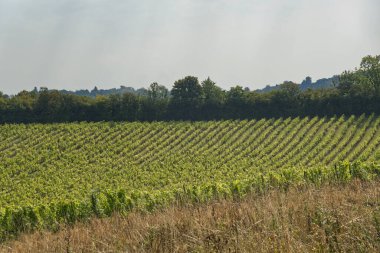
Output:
top-left (0, 115), bottom-right (380, 238)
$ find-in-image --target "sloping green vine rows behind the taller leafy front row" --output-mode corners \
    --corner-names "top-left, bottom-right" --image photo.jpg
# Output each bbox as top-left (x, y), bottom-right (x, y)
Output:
top-left (0, 115), bottom-right (380, 206)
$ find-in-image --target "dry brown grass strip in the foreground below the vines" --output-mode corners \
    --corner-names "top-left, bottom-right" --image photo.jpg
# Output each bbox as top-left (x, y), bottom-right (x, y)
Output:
top-left (0, 181), bottom-right (380, 252)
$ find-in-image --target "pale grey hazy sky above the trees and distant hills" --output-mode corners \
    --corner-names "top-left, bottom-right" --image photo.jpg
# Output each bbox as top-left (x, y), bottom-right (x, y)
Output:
top-left (0, 0), bottom-right (380, 93)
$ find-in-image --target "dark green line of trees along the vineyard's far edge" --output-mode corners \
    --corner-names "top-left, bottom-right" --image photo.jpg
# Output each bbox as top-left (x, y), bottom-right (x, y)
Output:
top-left (0, 55), bottom-right (380, 123)
